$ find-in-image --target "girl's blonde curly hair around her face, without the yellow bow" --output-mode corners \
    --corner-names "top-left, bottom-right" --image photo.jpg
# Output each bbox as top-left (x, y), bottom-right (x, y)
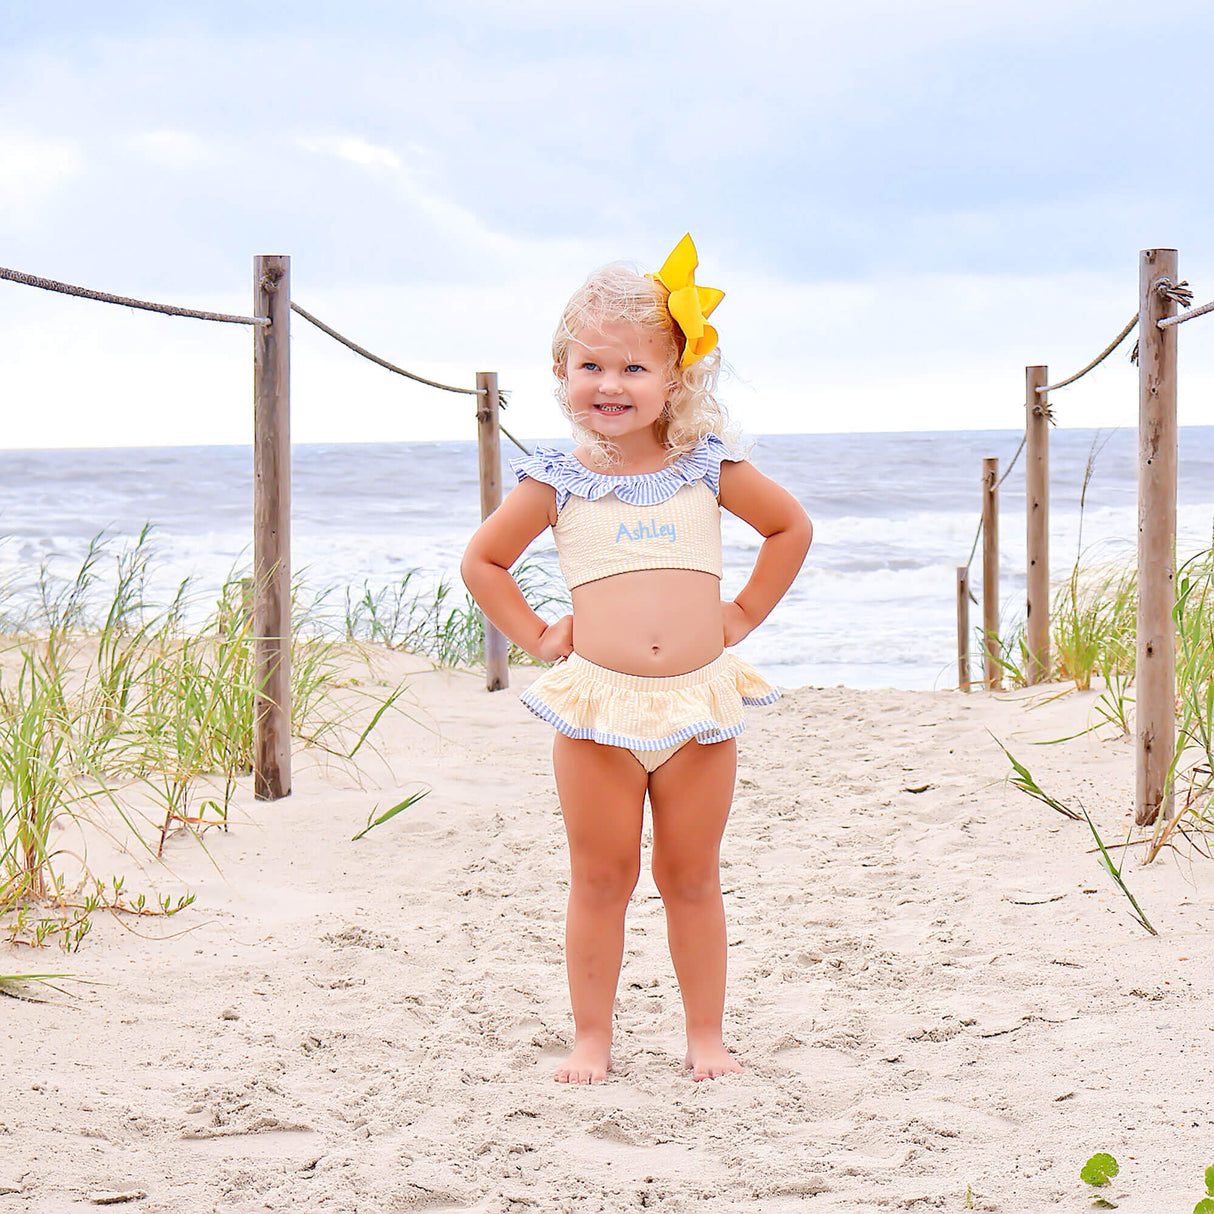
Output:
top-left (552, 261), bottom-right (738, 466)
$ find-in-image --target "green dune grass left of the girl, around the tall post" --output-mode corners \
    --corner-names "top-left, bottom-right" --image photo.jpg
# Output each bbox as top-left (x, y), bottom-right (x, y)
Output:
top-left (0, 528), bottom-right (483, 951)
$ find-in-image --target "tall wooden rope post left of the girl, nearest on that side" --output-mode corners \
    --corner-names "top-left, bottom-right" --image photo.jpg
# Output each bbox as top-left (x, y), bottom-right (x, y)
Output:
top-left (253, 256), bottom-right (291, 801)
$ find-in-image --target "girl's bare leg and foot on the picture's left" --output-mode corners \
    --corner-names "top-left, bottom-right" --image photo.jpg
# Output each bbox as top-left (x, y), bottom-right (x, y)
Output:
top-left (552, 733), bottom-right (648, 1083)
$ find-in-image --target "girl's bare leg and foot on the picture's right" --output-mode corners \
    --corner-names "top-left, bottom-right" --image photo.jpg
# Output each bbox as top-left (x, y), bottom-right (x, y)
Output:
top-left (649, 739), bottom-right (742, 1079)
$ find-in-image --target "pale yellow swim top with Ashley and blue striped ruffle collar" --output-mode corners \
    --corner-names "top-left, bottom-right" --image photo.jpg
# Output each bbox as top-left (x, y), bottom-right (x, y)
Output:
top-left (511, 435), bottom-right (742, 590)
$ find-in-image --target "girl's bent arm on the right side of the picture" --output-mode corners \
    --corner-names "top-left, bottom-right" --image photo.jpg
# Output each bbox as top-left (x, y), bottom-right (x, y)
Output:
top-left (721, 460), bottom-right (813, 645)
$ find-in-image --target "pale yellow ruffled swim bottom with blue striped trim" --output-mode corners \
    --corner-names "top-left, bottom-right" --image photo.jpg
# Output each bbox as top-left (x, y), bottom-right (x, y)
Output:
top-left (521, 651), bottom-right (779, 771)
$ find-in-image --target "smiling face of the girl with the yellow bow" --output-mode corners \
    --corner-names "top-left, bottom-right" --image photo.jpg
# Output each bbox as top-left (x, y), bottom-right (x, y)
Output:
top-left (554, 320), bottom-right (675, 438)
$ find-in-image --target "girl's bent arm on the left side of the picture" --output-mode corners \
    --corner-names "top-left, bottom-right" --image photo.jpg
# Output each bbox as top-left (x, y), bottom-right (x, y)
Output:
top-left (460, 478), bottom-right (573, 662)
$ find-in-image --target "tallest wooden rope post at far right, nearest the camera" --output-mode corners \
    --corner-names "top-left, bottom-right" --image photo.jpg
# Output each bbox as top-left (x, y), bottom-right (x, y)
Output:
top-left (1134, 249), bottom-right (1179, 827)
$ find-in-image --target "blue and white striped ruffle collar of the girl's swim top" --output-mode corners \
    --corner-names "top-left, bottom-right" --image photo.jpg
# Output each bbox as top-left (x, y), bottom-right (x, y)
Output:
top-left (510, 435), bottom-right (745, 510)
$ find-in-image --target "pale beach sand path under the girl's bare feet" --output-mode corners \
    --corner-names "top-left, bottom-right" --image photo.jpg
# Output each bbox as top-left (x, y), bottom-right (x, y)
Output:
top-left (0, 656), bottom-right (1214, 1214)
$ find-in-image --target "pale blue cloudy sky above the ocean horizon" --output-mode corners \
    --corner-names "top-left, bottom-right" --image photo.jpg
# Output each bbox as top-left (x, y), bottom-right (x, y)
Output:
top-left (0, 0), bottom-right (1214, 448)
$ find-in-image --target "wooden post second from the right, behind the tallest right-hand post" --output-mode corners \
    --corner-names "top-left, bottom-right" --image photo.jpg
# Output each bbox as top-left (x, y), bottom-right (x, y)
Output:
top-left (1025, 367), bottom-right (1050, 685)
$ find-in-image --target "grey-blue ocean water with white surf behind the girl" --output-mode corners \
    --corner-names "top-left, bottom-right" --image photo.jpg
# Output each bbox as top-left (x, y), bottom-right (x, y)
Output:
top-left (0, 426), bottom-right (1214, 688)
